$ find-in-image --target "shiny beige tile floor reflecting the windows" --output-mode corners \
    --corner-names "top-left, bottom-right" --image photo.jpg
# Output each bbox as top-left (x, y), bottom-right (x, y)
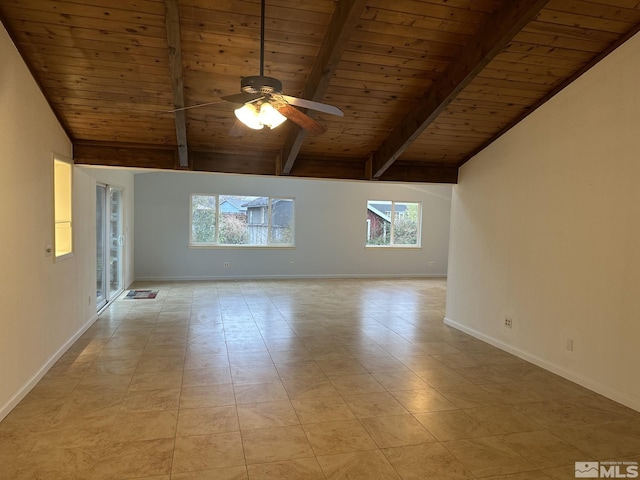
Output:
top-left (0, 279), bottom-right (640, 480)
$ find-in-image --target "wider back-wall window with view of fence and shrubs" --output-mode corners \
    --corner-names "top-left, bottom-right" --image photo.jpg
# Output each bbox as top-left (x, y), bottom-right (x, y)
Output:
top-left (189, 194), bottom-right (294, 247)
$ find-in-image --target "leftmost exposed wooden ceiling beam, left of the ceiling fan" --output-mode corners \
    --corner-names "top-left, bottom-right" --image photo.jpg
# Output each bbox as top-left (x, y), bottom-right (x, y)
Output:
top-left (164, 0), bottom-right (189, 167)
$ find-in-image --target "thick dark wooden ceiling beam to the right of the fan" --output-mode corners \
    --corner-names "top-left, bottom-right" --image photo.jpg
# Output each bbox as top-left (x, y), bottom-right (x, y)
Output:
top-left (372, 0), bottom-right (548, 178)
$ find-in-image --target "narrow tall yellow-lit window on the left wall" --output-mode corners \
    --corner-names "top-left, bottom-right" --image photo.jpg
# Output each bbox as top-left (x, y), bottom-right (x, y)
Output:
top-left (53, 155), bottom-right (73, 261)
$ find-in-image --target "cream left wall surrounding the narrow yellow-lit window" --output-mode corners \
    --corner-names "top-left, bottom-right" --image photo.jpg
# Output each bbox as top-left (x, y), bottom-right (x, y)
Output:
top-left (0, 27), bottom-right (133, 420)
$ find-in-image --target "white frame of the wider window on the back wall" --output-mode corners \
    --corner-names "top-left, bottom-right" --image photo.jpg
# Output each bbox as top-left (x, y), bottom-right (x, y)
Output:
top-left (188, 193), bottom-right (296, 250)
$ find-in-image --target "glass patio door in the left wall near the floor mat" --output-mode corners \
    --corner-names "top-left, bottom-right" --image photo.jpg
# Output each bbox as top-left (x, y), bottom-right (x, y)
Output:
top-left (96, 185), bottom-right (124, 310)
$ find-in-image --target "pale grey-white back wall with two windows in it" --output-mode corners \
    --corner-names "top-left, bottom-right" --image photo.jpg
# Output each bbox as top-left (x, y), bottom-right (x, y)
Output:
top-left (135, 172), bottom-right (451, 280)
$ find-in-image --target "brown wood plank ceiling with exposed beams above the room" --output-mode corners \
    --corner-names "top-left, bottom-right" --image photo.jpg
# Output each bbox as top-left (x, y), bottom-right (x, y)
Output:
top-left (0, 0), bottom-right (640, 183)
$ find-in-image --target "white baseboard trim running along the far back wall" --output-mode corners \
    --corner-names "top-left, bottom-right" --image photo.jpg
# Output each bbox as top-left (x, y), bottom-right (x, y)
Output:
top-left (135, 273), bottom-right (447, 282)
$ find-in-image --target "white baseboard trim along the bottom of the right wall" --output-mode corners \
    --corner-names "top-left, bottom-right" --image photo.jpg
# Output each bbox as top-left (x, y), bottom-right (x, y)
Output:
top-left (444, 317), bottom-right (640, 412)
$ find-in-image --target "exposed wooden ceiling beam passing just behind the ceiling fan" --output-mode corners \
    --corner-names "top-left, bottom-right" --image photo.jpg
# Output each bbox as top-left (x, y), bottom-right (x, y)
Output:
top-left (282, 0), bottom-right (367, 175)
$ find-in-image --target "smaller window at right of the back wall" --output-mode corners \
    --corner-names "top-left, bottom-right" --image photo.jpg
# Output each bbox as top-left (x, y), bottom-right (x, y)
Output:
top-left (366, 200), bottom-right (422, 248)
